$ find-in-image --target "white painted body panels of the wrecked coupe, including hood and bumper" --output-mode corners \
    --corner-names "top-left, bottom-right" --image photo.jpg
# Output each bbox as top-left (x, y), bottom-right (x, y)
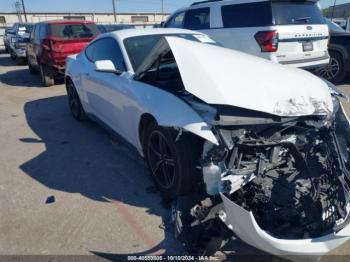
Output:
top-left (66, 29), bottom-right (350, 255)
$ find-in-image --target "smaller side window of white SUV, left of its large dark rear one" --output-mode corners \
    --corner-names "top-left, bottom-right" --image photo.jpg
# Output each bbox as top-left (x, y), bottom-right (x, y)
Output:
top-left (184, 7), bottom-right (210, 30)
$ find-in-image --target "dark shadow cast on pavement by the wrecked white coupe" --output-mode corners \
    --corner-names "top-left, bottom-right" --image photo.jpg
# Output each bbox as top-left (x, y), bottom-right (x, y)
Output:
top-left (20, 96), bottom-right (261, 257)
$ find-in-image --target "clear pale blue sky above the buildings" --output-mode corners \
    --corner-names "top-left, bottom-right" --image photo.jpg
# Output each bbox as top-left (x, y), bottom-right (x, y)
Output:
top-left (0, 0), bottom-right (350, 12)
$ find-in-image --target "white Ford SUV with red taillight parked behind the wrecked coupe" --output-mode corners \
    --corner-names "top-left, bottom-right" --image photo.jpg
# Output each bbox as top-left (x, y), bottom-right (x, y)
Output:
top-left (164, 0), bottom-right (329, 69)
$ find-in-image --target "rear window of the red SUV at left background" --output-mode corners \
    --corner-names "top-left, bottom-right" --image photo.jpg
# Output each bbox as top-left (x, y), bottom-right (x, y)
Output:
top-left (49, 24), bottom-right (99, 38)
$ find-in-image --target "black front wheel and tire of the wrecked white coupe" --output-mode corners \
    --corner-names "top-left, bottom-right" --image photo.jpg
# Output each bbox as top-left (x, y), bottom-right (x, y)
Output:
top-left (144, 123), bottom-right (202, 199)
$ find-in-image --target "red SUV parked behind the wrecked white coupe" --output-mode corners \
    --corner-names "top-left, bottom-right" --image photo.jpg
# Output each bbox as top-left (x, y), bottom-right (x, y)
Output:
top-left (27, 20), bottom-right (99, 86)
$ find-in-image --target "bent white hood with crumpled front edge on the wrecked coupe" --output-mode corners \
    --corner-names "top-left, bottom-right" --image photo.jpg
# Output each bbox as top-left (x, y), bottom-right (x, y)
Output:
top-left (166, 37), bottom-right (333, 116)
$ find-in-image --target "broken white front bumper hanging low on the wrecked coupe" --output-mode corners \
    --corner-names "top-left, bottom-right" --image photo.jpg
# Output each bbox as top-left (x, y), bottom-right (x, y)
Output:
top-left (220, 194), bottom-right (350, 257)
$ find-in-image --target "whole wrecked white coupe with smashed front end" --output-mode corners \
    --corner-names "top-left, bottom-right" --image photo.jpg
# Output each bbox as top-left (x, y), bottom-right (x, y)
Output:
top-left (66, 29), bottom-right (350, 256)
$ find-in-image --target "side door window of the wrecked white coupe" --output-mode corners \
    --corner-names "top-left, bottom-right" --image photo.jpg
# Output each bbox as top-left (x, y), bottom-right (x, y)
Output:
top-left (91, 38), bottom-right (126, 71)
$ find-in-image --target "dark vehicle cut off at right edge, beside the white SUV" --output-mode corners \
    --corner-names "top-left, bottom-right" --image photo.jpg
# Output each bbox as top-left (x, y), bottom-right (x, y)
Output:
top-left (315, 19), bottom-right (350, 84)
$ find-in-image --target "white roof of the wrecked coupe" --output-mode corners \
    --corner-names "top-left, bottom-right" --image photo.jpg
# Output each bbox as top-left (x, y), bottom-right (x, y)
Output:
top-left (109, 28), bottom-right (203, 40)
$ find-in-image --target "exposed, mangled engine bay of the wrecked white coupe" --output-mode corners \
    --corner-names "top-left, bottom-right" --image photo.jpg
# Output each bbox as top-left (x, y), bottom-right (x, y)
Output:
top-left (198, 97), bottom-right (350, 240)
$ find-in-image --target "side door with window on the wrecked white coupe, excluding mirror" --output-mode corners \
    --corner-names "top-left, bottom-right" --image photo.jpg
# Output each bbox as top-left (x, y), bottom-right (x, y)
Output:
top-left (83, 37), bottom-right (129, 138)
